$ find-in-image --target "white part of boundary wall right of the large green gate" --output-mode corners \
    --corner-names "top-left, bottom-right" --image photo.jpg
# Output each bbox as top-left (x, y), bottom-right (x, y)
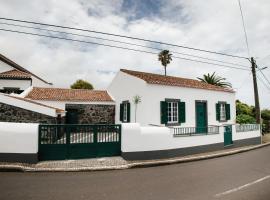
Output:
top-left (121, 123), bottom-right (260, 152)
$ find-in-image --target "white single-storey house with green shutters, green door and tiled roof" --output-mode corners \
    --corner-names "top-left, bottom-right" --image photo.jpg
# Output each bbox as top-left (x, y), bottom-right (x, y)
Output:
top-left (108, 69), bottom-right (236, 128)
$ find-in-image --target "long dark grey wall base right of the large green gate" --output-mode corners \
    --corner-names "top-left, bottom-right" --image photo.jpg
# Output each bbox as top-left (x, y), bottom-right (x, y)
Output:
top-left (122, 137), bottom-right (261, 160)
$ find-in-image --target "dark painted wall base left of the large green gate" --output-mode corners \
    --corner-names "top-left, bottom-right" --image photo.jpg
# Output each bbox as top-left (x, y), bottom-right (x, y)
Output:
top-left (0, 153), bottom-right (38, 163)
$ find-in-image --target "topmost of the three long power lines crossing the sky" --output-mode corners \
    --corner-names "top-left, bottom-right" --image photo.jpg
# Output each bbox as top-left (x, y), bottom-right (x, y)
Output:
top-left (0, 17), bottom-right (248, 59)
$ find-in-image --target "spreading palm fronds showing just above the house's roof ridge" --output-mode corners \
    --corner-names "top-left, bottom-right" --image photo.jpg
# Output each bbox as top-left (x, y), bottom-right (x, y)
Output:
top-left (197, 72), bottom-right (232, 88)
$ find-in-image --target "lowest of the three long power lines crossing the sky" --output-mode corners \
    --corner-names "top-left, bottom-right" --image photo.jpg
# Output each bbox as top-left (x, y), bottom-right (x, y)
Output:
top-left (0, 28), bottom-right (249, 71)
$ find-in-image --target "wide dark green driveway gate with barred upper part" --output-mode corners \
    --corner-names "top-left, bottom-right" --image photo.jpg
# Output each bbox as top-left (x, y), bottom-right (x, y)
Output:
top-left (38, 124), bottom-right (121, 160)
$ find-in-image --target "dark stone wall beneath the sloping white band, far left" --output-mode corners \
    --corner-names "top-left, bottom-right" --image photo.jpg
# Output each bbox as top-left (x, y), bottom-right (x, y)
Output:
top-left (0, 103), bottom-right (56, 124)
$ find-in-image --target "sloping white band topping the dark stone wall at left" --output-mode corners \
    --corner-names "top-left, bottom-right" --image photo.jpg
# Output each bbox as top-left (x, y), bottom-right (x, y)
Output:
top-left (0, 93), bottom-right (57, 117)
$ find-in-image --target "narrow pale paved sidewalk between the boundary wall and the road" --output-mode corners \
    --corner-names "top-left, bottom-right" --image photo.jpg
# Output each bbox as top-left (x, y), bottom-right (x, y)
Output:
top-left (0, 139), bottom-right (270, 172)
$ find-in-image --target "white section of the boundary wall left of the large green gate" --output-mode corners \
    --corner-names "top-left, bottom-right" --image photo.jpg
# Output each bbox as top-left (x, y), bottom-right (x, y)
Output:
top-left (0, 122), bottom-right (38, 153)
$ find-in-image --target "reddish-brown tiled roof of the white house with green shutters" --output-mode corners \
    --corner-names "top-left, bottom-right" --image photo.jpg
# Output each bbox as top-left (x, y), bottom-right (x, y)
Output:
top-left (120, 69), bottom-right (234, 93)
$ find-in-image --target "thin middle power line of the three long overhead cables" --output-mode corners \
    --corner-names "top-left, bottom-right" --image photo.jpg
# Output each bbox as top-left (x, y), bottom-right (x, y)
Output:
top-left (0, 22), bottom-right (250, 67)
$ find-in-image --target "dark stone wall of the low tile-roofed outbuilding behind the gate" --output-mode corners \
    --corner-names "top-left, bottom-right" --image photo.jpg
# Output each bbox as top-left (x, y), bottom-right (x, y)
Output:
top-left (66, 104), bottom-right (115, 124)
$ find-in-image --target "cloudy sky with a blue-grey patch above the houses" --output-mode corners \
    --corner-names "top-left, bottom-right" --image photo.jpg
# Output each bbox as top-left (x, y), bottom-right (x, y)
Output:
top-left (0, 0), bottom-right (270, 108)
